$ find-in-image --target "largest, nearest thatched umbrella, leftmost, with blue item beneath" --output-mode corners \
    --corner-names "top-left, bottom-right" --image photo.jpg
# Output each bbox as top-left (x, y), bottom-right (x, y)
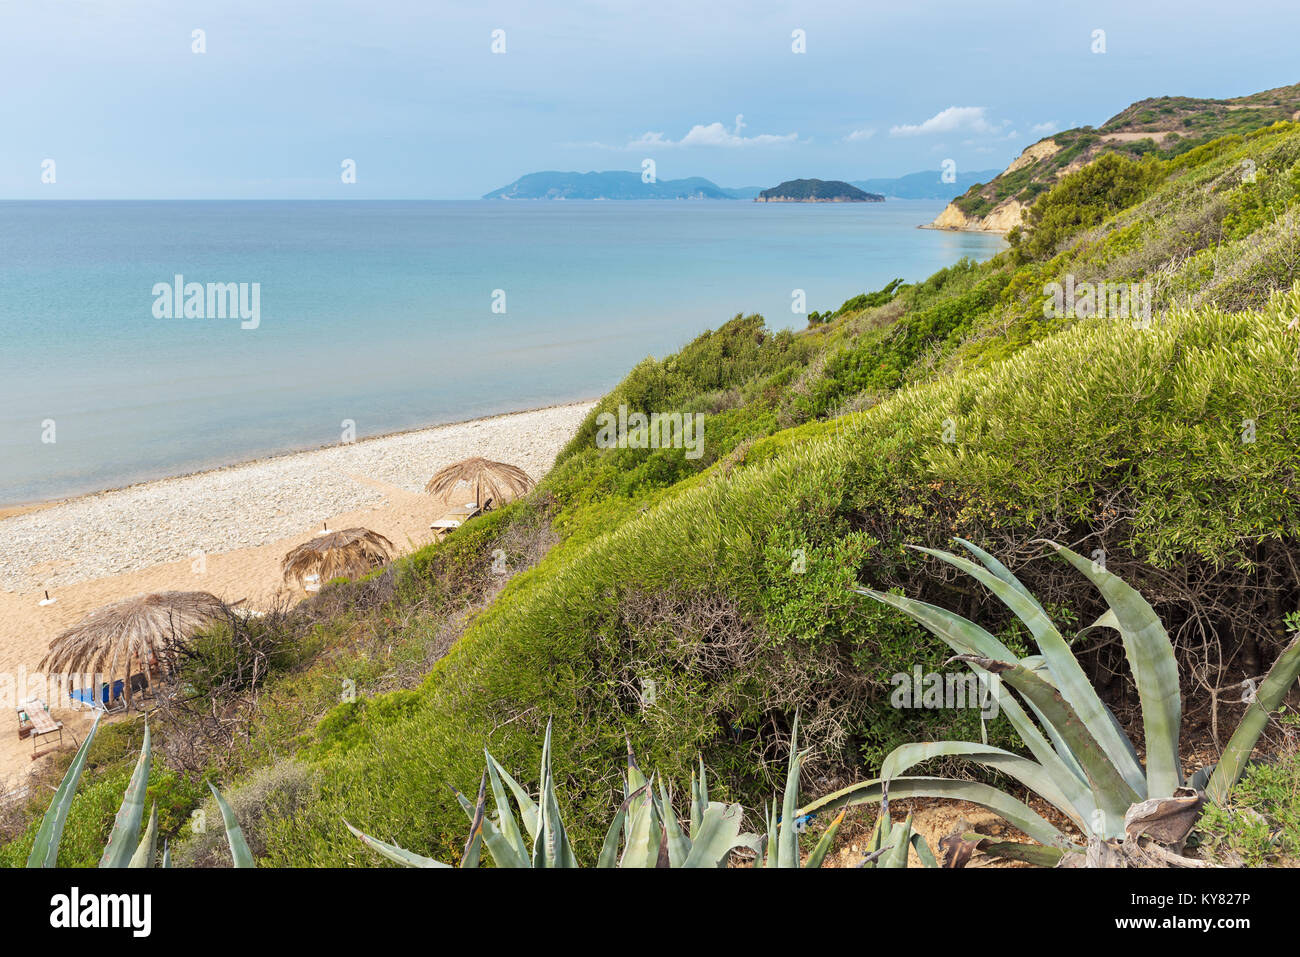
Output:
top-left (40, 592), bottom-right (226, 703)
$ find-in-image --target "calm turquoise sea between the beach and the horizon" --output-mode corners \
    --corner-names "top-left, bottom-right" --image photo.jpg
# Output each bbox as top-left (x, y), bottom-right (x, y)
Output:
top-left (0, 202), bottom-right (1002, 503)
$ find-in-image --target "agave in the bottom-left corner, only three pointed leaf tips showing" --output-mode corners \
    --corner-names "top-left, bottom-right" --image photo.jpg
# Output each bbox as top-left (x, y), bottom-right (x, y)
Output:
top-left (27, 715), bottom-right (254, 867)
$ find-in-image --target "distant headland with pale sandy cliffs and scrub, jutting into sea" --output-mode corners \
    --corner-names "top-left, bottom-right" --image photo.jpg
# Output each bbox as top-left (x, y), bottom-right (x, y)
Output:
top-left (931, 85), bottom-right (1300, 233)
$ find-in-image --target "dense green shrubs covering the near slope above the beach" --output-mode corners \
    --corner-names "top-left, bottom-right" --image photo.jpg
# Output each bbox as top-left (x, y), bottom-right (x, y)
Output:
top-left (0, 113), bottom-right (1300, 865)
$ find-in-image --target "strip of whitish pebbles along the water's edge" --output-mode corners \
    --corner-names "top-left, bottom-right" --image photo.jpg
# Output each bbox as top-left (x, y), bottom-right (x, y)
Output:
top-left (0, 402), bottom-right (593, 592)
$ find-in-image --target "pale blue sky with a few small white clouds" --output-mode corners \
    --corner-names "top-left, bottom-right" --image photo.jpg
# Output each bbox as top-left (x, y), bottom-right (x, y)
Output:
top-left (0, 0), bottom-right (1300, 199)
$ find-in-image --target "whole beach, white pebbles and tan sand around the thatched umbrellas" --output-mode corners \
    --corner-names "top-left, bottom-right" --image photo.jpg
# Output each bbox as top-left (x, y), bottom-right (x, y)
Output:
top-left (0, 402), bottom-right (593, 794)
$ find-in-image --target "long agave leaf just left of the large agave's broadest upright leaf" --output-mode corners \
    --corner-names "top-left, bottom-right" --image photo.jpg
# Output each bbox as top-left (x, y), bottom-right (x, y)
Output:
top-left (911, 546), bottom-right (1147, 794)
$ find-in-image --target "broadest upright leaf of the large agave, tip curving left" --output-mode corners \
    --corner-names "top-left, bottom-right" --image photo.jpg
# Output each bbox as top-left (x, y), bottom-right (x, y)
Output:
top-left (1049, 542), bottom-right (1183, 798)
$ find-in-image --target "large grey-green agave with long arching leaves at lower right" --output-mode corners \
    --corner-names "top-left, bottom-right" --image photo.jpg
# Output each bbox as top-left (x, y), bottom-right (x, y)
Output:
top-left (806, 538), bottom-right (1300, 862)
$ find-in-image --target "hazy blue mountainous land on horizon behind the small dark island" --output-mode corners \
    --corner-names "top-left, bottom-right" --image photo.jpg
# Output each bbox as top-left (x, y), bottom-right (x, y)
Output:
top-left (484, 169), bottom-right (998, 202)
